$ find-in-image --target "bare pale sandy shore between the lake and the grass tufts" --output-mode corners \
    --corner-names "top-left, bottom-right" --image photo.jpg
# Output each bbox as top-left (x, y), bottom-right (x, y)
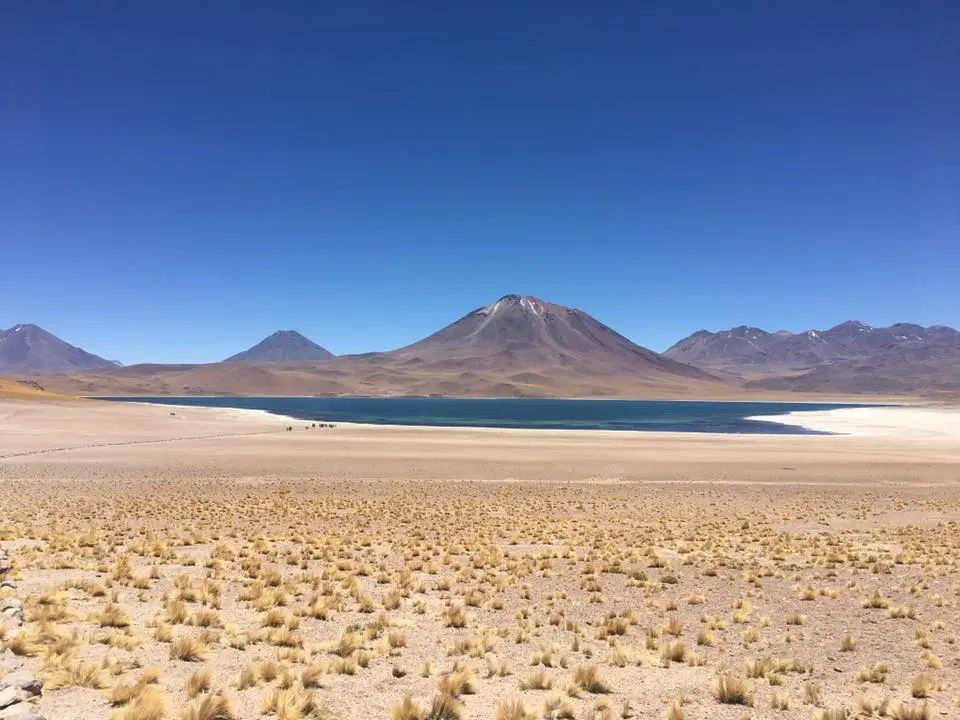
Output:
top-left (0, 401), bottom-right (960, 482)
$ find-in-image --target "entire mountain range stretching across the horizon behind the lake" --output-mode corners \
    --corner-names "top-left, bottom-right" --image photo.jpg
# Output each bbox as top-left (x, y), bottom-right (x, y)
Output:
top-left (0, 295), bottom-right (960, 398)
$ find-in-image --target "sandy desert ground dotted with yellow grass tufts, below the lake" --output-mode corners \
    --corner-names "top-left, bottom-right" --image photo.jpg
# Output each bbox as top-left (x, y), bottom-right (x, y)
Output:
top-left (0, 400), bottom-right (960, 720)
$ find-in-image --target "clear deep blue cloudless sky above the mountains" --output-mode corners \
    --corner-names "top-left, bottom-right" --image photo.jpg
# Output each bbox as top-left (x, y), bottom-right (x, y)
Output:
top-left (0, 0), bottom-right (960, 363)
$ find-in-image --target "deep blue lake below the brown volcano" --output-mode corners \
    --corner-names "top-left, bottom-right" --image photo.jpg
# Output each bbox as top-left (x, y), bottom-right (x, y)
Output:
top-left (95, 396), bottom-right (857, 435)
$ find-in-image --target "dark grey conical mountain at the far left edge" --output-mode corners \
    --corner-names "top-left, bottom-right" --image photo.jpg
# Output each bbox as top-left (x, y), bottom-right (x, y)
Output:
top-left (0, 324), bottom-right (119, 373)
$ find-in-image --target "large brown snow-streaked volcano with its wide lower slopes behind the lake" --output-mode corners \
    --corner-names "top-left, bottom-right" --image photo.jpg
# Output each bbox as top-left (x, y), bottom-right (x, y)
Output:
top-left (37, 295), bottom-right (728, 398)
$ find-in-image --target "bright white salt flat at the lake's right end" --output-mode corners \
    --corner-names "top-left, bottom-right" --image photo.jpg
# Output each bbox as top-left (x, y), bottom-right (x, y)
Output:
top-left (747, 406), bottom-right (960, 441)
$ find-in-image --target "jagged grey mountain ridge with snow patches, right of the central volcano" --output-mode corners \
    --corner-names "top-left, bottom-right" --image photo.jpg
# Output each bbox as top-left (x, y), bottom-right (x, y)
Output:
top-left (664, 320), bottom-right (960, 374)
